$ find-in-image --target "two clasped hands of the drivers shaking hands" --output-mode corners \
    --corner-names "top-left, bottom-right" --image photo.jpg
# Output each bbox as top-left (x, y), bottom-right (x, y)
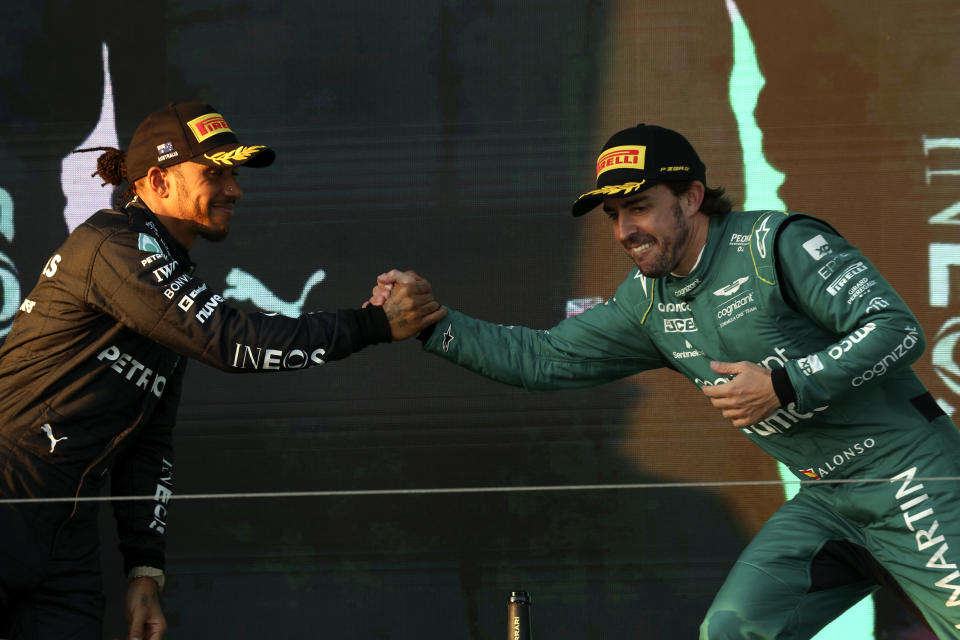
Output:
top-left (363, 269), bottom-right (447, 340)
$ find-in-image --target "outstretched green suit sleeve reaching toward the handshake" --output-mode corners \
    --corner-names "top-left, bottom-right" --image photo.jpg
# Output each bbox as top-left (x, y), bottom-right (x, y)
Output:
top-left (424, 288), bottom-right (665, 390)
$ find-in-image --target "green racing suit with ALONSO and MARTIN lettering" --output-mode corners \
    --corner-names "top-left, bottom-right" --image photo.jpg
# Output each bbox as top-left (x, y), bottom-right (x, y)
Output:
top-left (424, 211), bottom-right (960, 639)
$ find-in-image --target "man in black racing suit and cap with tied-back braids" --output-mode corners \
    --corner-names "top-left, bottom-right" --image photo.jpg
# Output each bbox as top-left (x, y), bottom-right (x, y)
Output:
top-left (0, 103), bottom-right (445, 640)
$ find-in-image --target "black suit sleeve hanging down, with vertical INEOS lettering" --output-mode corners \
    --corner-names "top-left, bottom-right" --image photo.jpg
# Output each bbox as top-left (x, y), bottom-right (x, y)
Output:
top-left (110, 358), bottom-right (187, 574)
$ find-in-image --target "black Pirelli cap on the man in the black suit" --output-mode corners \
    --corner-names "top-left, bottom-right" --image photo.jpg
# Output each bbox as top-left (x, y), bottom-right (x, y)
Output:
top-left (126, 102), bottom-right (277, 184)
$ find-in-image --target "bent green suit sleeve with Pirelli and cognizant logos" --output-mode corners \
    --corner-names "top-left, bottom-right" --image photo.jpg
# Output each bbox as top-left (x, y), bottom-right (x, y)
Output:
top-left (775, 217), bottom-right (926, 411)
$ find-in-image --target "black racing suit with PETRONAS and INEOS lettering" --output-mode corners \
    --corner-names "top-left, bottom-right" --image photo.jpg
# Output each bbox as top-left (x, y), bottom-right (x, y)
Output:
top-left (0, 200), bottom-right (390, 637)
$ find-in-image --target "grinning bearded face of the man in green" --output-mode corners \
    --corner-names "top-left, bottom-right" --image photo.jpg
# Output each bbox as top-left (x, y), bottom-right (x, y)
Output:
top-left (603, 183), bottom-right (706, 278)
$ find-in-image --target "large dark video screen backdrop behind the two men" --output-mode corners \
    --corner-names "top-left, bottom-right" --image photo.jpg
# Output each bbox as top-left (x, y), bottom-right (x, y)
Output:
top-left (0, 0), bottom-right (960, 640)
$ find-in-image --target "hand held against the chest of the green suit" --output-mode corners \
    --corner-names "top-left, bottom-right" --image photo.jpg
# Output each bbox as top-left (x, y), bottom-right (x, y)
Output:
top-left (703, 362), bottom-right (780, 427)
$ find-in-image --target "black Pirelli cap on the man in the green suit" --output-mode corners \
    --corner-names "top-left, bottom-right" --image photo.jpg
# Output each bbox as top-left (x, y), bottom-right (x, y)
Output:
top-left (573, 124), bottom-right (707, 216)
